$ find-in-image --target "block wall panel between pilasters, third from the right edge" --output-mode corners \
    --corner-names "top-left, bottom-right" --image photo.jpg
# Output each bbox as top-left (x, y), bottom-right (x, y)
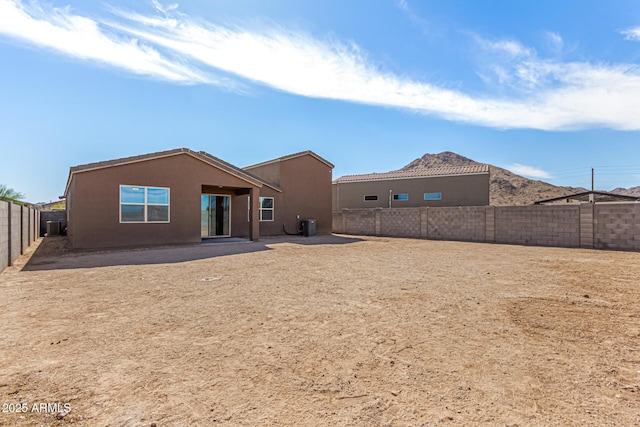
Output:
top-left (427, 206), bottom-right (487, 242)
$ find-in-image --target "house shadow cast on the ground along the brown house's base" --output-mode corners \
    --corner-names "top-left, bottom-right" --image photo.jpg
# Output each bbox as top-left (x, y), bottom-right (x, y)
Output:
top-left (22, 235), bottom-right (362, 271)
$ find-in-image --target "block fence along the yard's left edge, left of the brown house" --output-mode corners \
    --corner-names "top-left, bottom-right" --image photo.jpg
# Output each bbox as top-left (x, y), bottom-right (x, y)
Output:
top-left (0, 200), bottom-right (40, 273)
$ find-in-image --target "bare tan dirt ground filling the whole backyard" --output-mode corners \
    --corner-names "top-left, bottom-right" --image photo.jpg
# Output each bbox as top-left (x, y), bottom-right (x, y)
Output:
top-left (0, 236), bottom-right (640, 427)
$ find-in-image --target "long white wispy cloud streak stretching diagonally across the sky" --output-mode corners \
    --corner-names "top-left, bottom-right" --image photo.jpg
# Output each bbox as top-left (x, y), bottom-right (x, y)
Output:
top-left (0, 0), bottom-right (640, 130)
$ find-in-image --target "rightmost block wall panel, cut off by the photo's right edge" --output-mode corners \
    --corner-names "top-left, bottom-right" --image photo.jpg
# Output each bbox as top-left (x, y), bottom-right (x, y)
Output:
top-left (593, 203), bottom-right (640, 250)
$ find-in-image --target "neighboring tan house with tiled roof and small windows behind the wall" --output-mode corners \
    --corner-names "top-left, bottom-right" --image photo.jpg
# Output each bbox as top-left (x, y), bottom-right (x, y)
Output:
top-left (332, 165), bottom-right (489, 212)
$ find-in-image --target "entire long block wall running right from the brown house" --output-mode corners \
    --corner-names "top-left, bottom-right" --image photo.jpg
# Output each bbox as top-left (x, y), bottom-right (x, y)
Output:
top-left (333, 203), bottom-right (640, 251)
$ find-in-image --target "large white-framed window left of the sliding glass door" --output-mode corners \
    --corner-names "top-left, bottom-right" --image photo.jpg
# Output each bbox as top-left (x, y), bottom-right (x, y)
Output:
top-left (120, 185), bottom-right (169, 223)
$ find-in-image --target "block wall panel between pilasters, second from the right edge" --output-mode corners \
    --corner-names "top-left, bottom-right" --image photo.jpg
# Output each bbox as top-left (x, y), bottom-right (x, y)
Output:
top-left (495, 205), bottom-right (580, 248)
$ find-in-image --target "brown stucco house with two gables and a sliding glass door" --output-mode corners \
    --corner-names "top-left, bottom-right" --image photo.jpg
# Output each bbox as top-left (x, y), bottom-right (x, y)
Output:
top-left (65, 148), bottom-right (333, 248)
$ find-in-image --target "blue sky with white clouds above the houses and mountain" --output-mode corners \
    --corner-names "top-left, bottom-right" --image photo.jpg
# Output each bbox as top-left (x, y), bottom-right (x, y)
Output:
top-left (0, 0), bottom-right (640, 202)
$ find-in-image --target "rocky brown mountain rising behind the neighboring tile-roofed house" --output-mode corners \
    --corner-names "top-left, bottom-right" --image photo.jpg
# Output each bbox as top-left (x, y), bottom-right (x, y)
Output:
top-left (400, 151), bottom-right (588, 206)
